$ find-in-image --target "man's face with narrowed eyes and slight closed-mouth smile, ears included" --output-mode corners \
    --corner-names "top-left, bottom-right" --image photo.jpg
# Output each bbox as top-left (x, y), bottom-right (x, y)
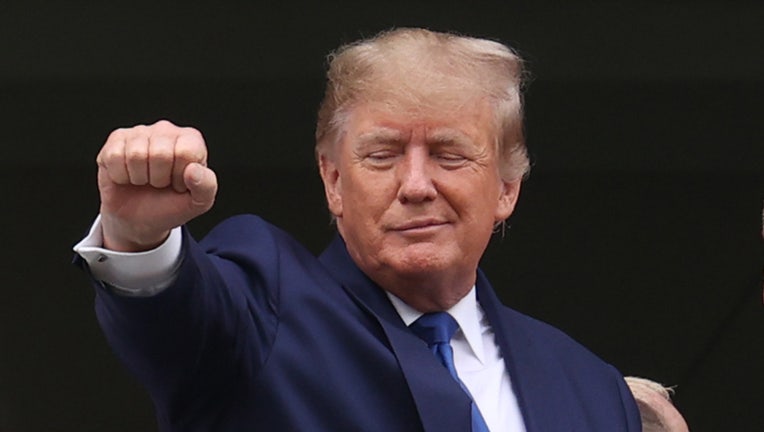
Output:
top-left (320, 98), bottom-right (520, 308)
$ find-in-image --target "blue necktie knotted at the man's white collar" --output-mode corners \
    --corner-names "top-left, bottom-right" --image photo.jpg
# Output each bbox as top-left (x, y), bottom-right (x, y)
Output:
top-left (409, 312), bottom-right (490, 432)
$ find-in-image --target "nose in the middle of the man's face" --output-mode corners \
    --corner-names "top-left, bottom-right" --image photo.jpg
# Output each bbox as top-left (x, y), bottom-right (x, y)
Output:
top-left (398, 146), bottom-right (438, 204)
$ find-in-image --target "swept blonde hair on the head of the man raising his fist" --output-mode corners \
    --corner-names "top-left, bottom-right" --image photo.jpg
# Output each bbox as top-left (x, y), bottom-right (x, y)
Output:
top-left (316, 28), bottom-right (530, 180)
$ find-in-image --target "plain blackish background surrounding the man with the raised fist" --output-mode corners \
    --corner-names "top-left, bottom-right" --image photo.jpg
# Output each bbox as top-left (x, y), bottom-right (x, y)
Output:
top-left (0, 1), bottom-right (764, 432)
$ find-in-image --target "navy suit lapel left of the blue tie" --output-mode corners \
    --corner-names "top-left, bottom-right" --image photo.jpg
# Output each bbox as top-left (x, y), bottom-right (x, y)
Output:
top-left (319, 236), bottom-right (471, 432)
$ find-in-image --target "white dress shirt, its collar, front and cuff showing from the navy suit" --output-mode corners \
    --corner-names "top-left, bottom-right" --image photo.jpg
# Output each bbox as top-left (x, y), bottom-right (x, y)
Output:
top-left (74, 216), bottom-right (525, 432)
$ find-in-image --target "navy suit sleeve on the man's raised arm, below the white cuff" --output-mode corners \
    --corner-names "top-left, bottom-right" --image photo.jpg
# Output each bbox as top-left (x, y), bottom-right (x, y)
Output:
top-left (96, 217), bottom-right (281, 422)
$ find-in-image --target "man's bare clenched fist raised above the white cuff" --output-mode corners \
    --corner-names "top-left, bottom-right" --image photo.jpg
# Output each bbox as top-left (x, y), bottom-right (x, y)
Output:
top-left (96, 120), bottom-right (217, 252)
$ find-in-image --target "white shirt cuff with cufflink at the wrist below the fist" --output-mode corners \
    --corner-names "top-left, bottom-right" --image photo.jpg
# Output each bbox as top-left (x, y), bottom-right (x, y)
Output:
top-left (74, 215), bottom-right (182, 297)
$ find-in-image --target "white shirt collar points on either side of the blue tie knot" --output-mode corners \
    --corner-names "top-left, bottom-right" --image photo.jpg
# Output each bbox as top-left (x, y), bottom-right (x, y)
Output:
top-left (385, 285), bottom-right (485, 363)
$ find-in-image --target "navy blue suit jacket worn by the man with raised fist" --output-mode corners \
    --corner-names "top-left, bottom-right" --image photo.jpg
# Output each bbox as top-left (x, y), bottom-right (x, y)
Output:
top-left (88, 216), bottom-right (641, 432)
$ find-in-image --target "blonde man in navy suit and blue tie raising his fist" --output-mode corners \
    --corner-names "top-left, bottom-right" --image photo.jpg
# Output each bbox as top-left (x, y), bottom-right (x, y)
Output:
top-left (76, 29), bottom-right (640, 432)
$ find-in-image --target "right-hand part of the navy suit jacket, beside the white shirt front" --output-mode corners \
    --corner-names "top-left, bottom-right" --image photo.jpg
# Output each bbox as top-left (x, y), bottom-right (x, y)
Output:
top-left (477, 272), bottom-right (641, 432)
